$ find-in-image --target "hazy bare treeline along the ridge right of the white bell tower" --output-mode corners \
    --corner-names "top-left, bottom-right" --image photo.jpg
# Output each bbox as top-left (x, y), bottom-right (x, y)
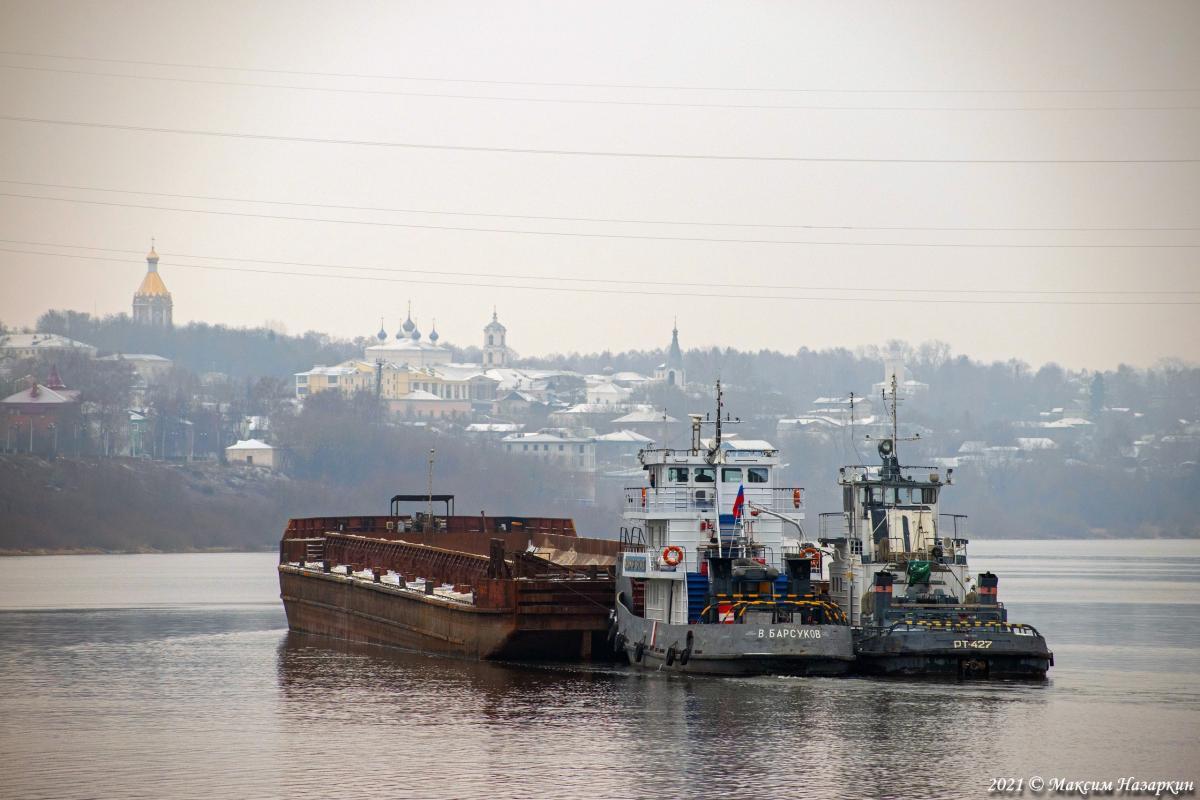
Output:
top-left (527, 341), bottom-right (1200, 432)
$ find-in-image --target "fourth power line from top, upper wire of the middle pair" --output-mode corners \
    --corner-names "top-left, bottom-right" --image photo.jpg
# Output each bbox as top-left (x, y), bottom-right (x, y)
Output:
top-left (0, 178), bottom-right (1200, 233)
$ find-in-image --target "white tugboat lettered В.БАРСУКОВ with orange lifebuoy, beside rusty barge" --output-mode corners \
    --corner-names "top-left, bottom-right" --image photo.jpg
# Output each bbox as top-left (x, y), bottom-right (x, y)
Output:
top-left (610, 381), bottom-right (854, 675)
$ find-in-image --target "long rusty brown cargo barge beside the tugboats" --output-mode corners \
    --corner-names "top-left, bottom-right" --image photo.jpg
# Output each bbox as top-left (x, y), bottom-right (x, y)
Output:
top-left (278, 494), bottom-right (619, 661)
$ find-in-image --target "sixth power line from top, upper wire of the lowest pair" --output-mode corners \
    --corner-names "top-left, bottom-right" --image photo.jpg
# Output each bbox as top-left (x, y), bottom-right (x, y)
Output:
top-left (0, 239), bottom-right (1200, 295)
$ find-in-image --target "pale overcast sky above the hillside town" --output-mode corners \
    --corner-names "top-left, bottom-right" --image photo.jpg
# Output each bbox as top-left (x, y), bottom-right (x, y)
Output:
top-left (0, 0), bottom-right (1200, 368)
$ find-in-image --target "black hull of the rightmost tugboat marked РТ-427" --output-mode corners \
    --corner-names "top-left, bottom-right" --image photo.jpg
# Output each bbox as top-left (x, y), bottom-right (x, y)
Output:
top-left (854, 626), bottom-right (1054, 680)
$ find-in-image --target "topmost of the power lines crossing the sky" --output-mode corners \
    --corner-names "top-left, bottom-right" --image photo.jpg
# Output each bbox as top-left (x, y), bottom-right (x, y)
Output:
top-left (0, 50), bottom-right (1200, 95)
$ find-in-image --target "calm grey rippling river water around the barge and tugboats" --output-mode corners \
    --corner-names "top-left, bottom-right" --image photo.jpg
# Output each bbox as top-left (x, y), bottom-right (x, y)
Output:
top-left (0, 542), bottom-right (1200, 800)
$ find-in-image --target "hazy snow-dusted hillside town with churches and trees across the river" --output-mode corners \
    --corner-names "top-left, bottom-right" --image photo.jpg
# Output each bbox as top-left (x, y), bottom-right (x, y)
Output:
top-left (0, 247), bottom-right (1200, 532)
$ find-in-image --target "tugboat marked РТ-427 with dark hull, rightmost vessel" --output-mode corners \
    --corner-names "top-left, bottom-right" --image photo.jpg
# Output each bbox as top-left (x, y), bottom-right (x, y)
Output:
top-left (820, 377), bottom-right (1054, 678)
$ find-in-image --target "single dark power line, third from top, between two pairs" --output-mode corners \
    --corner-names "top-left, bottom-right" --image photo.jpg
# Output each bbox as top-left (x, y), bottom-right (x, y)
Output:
top-left (0, 114), bottom-right (1200, 164)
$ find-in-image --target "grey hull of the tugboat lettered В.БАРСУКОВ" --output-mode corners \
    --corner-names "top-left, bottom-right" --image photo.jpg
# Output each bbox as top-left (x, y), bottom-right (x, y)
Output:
top-left (614, 601), bottom-right (854, 675)
